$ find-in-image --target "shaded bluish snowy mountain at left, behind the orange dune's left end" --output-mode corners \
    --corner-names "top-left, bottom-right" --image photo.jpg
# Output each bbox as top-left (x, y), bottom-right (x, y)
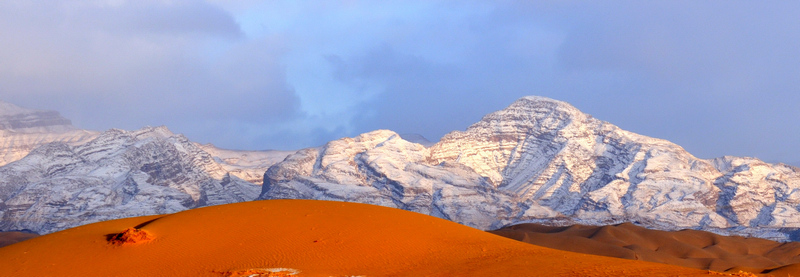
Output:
top-left (0, 127), bottom-right (260, 233)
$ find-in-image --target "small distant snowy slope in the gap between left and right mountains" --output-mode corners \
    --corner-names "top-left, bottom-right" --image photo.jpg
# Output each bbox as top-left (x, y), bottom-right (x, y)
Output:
top-left (196, 143), bottom-right (295, 185)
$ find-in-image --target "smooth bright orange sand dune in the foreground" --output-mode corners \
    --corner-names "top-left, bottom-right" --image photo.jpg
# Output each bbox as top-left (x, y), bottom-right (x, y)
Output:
top-left (0, 200), bottom-right (720, 276)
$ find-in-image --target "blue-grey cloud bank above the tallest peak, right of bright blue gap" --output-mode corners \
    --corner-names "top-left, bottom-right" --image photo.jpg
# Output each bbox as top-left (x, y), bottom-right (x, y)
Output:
top-left (320, 1), bottom-right (800, 161)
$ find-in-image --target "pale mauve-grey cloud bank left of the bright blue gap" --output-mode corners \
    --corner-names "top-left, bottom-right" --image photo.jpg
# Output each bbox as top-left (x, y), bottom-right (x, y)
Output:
top-left (0, 1), bottom-right (302, 148)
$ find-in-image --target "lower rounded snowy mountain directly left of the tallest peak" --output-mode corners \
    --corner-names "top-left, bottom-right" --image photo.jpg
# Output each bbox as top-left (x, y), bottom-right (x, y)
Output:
top-left (261, 130), bottom-right (505, 227)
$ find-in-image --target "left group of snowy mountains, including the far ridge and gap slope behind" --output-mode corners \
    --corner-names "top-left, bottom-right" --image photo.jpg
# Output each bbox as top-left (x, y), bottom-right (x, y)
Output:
top-left (0, 100), bottom-right (287, 234)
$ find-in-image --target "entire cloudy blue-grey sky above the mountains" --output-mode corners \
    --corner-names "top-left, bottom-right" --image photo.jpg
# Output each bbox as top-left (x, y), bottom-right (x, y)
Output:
top-left (0, 0), bottom-right (800, 165)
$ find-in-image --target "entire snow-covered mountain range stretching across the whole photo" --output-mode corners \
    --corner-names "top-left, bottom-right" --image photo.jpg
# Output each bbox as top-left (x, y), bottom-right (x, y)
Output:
top-left (0, 97), bottom-right (800, 240)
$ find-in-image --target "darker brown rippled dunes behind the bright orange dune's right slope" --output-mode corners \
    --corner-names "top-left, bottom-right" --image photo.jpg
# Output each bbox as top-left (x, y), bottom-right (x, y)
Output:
top-left (491, 223), bottom-right (800, 276)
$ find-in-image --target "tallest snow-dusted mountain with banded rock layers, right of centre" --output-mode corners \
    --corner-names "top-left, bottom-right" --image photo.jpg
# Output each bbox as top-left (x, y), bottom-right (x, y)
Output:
top-left (431, 97), bottom-right (731, 228)
